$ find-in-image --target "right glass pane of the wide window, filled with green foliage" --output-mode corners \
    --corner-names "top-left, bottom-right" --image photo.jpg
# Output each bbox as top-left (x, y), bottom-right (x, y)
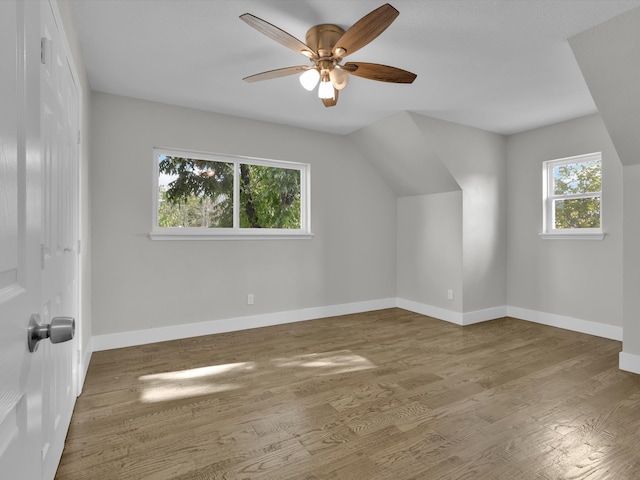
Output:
top-left (240, 164), bottom-right (300, 229)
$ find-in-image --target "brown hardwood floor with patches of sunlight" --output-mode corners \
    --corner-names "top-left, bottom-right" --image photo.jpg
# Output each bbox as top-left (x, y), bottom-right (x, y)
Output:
top-left (56, 309), bottom-right (640, 480)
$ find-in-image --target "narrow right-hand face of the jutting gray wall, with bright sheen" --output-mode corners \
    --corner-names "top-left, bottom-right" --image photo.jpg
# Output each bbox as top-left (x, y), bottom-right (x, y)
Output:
top-left (412, 114), bottom-right (507, 313)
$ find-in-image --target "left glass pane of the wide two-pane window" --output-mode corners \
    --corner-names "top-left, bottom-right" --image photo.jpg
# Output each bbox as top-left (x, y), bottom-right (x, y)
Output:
top-left (158, 155), bottom-right (233, 228)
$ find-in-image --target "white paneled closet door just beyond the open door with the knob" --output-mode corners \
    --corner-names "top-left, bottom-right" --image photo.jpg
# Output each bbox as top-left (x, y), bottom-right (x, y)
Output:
top-left (40, 1), bottom-right (79, 478)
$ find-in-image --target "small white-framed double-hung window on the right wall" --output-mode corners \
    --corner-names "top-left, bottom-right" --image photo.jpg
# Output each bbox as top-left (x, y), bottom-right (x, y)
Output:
top-left (541, 152), bottom-right (604, 239)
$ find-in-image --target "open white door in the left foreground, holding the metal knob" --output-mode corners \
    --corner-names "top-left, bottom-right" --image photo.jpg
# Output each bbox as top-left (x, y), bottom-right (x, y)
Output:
top-left (0, 0), bottom-right (42, 480)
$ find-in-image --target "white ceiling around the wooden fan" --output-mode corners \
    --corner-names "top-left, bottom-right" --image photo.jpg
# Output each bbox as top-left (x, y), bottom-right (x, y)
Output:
top-left (73, 0), bottom-right (640, 134)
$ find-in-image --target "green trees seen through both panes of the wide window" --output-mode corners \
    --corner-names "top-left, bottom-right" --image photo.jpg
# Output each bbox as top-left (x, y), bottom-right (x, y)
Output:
top-left (158, 155), bottom-right (301, 229)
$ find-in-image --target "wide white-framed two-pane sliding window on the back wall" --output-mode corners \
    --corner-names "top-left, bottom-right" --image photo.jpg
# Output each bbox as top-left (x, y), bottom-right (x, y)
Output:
top-left (151, 148), bottom-right (311, 240)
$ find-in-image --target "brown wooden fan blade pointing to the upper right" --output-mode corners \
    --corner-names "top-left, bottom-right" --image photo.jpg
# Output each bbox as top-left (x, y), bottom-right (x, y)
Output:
top-left (333, 3), bottom-right (400, 58)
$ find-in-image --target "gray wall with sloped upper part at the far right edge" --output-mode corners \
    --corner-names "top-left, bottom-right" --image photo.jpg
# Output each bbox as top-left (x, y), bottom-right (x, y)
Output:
top-left (569, 4), bottom-right (640, 364)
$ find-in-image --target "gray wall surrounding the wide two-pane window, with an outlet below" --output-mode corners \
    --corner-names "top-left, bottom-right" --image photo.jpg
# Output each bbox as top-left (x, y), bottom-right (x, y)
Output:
top-left (91, 93), bottom-right (396, 335)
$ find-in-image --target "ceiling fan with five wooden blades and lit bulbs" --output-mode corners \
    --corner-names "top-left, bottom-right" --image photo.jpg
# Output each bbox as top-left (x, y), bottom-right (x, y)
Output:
top-left (240, 3), bottom-right (416, 107)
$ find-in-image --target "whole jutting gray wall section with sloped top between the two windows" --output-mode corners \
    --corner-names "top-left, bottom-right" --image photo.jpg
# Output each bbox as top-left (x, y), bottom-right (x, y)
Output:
top-left (349, 112), bottom-right (506, 313)
